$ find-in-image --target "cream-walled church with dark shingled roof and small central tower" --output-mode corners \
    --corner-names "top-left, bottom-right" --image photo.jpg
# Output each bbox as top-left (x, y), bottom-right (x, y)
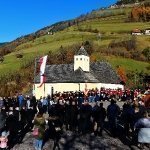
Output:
top-left (34, 46), bottom-right (124, 99)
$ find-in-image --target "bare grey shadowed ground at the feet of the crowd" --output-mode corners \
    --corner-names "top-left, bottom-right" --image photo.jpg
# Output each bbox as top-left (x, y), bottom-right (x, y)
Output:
top-left (12, 131), bottom-right (135, 150)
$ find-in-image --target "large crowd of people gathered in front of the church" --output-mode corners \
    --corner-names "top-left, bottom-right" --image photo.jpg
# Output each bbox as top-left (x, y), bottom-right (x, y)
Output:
top-left (0, 89), bottom-right (150, 150)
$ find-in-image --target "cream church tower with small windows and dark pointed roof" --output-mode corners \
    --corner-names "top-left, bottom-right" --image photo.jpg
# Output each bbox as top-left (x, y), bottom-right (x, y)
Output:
top-left (74, 46), bottom-right (90, 72)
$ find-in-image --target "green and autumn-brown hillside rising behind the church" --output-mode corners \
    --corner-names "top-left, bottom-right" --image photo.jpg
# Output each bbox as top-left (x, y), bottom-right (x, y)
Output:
top-left (0, 2), bottom-right (150, 95)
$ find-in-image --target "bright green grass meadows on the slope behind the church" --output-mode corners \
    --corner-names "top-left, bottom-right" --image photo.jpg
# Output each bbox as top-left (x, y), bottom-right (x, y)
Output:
top-left (0, 6), bottom-right (150, 74)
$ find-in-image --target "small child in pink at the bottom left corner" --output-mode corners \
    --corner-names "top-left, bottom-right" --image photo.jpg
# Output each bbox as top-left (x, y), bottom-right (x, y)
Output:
top-left (0, 131), bottom-right (9, 150)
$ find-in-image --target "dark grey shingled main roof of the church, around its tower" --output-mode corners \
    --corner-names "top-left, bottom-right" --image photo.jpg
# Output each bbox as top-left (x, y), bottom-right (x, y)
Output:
top-left (35, 62), bottom-right (120, 84)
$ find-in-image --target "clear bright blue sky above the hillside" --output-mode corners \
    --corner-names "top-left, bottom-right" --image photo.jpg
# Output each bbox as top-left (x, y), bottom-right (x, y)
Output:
top-left (0, 0), bottom-right (117, 42)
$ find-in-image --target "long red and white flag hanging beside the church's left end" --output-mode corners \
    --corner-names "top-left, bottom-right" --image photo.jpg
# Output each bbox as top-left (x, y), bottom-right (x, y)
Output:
top-left (38, 55), bottom-right (47, 87)
